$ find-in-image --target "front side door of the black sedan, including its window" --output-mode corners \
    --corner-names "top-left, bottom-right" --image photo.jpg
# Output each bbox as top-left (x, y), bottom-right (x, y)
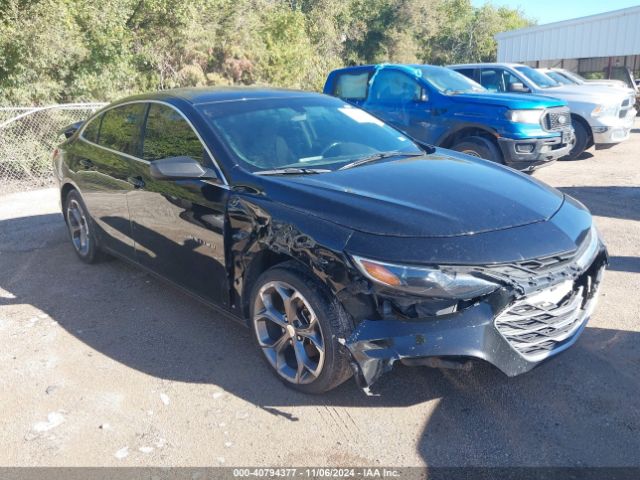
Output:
top-left (127, 103), bottom-right (228, 305)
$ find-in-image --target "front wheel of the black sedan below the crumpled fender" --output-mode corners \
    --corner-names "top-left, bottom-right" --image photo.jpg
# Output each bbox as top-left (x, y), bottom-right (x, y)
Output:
top-left (251, 262), bottom-right (353, 394)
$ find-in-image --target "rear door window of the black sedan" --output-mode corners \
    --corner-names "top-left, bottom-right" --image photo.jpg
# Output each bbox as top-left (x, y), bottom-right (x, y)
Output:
top-left (98, 103), bottom-right (144, 156)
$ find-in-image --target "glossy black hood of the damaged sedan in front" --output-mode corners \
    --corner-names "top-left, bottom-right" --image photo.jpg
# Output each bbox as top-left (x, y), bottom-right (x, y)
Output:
top-left (265, 149), bottom-right (564, 237)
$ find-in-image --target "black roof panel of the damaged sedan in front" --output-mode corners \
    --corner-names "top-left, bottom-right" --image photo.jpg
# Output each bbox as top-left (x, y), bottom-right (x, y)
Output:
top-left (110, 87), bottom-right (320, 105)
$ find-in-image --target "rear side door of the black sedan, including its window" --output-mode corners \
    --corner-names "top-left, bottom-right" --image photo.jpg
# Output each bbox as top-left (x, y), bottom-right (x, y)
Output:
top-left (74, 103), bottom-right (145, 257)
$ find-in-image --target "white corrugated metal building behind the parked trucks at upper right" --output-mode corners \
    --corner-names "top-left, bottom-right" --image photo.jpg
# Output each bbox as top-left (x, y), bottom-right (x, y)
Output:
top-left (495, 6), bottom-right (640, 77)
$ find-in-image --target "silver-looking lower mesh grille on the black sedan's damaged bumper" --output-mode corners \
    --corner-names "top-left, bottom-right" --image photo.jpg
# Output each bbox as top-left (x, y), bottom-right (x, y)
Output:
top-left (495, 284), bottom-right (586, 361)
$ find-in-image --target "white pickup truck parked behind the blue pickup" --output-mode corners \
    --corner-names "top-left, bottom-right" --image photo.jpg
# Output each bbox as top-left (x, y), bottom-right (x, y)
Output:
top-left (449, 63), bottom-right (636, 159)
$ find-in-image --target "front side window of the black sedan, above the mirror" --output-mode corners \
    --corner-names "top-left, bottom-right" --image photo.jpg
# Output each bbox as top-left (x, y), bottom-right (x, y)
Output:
top-left (143, 103), bottom-right (204, 163)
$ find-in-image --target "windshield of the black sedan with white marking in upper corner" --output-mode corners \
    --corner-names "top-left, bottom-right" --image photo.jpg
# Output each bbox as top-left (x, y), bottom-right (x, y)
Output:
top-left (198, 96), bottom-right (422, 173)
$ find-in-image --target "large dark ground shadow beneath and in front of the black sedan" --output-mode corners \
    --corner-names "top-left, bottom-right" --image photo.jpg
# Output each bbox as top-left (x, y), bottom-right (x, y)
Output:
top-left (0, 214), bottom-right (640, 466)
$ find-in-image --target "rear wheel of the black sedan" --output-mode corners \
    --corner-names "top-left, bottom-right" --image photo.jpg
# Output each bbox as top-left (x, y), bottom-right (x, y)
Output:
top-left (62, 190), bottom-right (104, 263)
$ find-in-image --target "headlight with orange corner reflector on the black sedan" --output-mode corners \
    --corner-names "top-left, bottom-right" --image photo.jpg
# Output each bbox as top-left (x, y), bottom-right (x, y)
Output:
top-left (353, 256), bottom-right (499, 300)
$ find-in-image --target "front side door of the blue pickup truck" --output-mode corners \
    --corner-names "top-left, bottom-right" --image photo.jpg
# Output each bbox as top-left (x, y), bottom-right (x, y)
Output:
top-left (362, 69), bottom-right (438, 143)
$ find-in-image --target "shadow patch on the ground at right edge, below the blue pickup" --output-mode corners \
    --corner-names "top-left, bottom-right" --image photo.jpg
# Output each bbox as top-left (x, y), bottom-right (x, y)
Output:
top-left (560, 185), bottom-right (640, 220)
